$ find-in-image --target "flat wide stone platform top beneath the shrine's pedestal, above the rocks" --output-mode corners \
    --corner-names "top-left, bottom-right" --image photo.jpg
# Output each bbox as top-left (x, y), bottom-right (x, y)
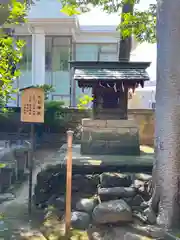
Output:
top-left (54, 144), bottom-right (154, 173)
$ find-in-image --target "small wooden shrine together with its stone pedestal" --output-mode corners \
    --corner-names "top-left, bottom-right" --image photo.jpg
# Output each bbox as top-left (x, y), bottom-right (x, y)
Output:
top-left (71, 61), bottom-right (150, 155)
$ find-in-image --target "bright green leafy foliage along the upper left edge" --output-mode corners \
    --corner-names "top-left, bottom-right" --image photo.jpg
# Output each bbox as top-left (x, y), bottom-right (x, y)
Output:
top-left (0, 0), bottom-right (26, 108)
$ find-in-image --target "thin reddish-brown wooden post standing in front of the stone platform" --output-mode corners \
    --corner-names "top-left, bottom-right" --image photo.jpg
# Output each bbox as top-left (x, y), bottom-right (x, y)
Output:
top-left (65, 131), bottom-right (73, 239)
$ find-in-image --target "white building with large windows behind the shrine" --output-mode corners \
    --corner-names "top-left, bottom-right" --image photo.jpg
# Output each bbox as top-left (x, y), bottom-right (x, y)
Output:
top-left (9, 0), bottom-right (156, 106)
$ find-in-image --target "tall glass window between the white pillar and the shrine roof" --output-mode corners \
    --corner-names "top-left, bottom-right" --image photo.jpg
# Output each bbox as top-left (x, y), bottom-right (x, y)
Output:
top-left (45, 36), bottom-right (72, 102)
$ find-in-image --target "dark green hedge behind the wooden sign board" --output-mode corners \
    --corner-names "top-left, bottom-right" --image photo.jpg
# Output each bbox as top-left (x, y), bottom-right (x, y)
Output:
top-left (0, 101), bottom-right (91, 133)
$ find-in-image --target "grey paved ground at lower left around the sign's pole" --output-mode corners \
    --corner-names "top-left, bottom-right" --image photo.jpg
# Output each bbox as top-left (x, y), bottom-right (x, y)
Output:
top-left (0, 149), bottom-right (56, 240)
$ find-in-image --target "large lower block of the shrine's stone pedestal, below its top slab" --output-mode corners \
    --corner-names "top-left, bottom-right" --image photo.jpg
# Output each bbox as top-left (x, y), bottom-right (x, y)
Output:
top-left (81, 128), bottom-right (140, 155)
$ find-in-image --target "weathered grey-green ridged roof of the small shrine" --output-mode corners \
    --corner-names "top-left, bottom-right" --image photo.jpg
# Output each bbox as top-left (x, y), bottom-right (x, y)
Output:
top-left (70, 62), bottom-right (150, 82)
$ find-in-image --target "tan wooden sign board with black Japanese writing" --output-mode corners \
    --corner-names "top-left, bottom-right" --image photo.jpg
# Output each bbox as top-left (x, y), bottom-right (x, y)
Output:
top-left (21, 88), bottom-right (44, 123)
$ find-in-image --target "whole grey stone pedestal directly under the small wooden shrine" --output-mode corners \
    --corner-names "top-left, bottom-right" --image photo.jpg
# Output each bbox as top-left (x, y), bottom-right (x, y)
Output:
top-left (81, 119), bottom-right (140, 155)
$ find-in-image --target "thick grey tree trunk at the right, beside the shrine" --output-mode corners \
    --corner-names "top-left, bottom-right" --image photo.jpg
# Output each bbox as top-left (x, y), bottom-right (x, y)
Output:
top-left (155, 0), bottom-right (180, 228)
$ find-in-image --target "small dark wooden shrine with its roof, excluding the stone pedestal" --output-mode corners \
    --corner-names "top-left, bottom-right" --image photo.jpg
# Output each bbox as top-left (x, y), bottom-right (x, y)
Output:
top-left (71, 62), bottom-right (150, 119)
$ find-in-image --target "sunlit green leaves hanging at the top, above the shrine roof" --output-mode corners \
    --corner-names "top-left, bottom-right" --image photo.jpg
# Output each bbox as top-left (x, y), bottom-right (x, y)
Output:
top-left (61, 0), bottom-right (156, 43)
